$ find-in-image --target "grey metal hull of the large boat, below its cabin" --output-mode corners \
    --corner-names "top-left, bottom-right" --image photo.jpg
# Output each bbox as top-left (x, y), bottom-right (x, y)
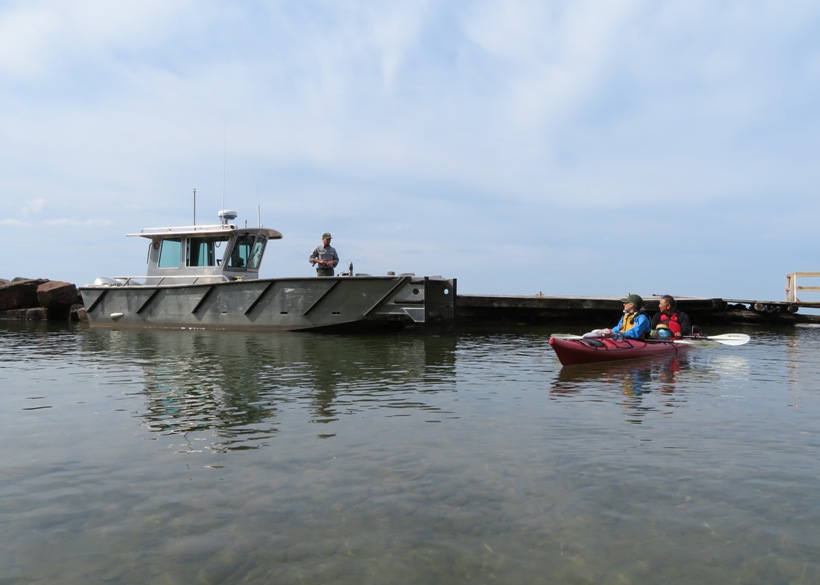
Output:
top-left (80, 275), bottom-right (456, 331)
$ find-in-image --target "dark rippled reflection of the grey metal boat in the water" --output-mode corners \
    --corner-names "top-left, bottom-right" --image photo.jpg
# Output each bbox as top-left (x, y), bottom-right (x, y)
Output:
top-left (83, 330), bottom-right (455, 451)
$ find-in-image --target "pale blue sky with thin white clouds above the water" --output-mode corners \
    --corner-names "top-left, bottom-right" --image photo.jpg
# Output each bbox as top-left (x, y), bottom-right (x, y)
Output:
top-left (0, 0), bottom-right (820, 301)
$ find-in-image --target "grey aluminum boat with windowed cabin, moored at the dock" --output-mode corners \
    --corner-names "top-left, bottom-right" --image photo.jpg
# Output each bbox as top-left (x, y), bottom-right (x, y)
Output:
top-left (80, 210), bottom-right (456, 331)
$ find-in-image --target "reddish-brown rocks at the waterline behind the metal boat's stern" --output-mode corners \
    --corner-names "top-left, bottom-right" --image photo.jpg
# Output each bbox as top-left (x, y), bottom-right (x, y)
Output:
top-left (0, 278), bottom-right (87, 321)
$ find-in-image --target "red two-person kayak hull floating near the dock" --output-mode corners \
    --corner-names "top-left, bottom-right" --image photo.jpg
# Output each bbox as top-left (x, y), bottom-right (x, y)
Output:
top-left (550, 337), bottom-right (686, 366)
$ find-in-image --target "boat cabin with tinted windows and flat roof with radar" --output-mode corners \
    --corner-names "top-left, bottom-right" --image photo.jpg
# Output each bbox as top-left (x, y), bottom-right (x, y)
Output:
top-left (126, 210), bottom-right (282, 285)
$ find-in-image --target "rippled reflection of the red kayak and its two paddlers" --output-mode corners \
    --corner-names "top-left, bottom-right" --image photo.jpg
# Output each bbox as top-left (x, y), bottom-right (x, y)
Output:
top-left (550, 354), bottom-right (691, 424)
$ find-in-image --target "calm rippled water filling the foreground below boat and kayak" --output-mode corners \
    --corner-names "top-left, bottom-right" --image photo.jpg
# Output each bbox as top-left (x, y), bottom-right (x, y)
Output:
top-left (0, 323), bottom-right (820, 585)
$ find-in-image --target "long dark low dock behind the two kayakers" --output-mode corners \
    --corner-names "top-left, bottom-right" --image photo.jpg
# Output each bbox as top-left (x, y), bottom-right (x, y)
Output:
top-left (456, 294), bottom-right (820, 328)
